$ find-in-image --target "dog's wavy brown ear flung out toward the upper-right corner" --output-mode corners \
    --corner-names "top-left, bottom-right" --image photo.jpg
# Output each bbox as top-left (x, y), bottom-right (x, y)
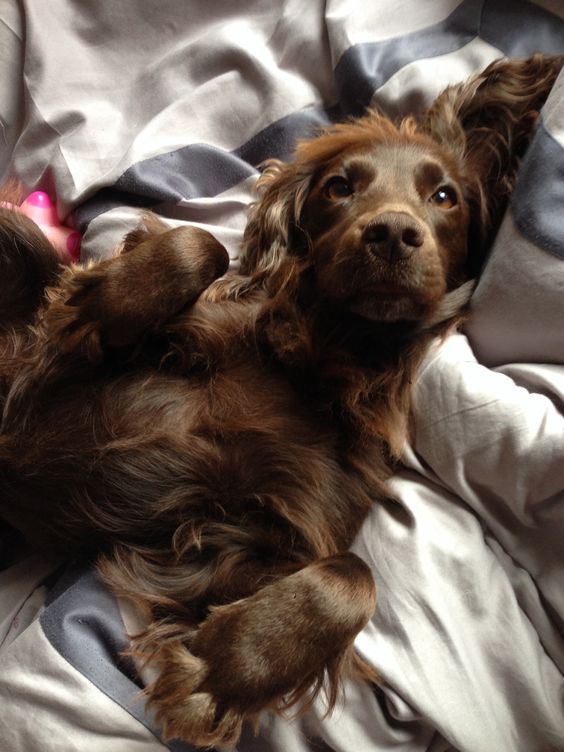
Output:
top-left (422, 54), bottom-right (564, 274)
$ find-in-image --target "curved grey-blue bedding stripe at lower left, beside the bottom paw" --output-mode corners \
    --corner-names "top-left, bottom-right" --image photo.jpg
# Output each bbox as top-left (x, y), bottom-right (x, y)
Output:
top-left (40, 568), bottom-right (195, 752)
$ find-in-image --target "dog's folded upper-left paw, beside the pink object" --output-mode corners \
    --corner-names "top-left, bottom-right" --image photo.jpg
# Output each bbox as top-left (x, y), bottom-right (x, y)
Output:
top-left (46, 227), bottom-right (229, 359)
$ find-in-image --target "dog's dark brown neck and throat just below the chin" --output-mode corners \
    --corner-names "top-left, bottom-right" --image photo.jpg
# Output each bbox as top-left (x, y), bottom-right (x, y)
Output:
top-left (257, 264), bottom-right (473, 456)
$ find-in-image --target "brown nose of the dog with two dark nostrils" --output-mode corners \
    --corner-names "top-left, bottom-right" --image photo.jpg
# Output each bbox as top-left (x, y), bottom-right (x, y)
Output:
top-left (362, 212), bottom-right (424, 262)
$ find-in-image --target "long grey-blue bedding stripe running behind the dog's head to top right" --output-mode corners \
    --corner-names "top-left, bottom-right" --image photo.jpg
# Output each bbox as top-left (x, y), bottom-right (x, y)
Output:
top-left (73, 0), bottom-right (564, 232)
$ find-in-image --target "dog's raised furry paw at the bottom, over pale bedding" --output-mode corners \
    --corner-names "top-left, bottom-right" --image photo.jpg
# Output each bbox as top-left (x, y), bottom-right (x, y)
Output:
top-left (124, 553), bottom-right (375, 748)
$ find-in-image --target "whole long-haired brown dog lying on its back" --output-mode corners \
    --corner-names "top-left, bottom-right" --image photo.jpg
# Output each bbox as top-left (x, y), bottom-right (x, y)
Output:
top-left (0, 56), bottom-right (562, 746)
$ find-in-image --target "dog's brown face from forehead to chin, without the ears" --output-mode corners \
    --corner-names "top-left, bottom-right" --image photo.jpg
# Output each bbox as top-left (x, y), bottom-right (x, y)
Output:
top-left (299, 138), bottom-right (469, 321)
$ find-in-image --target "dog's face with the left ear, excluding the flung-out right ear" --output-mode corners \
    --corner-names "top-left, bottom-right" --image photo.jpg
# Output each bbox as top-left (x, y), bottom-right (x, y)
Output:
top-left (243, 113), bottom-right (476, 322)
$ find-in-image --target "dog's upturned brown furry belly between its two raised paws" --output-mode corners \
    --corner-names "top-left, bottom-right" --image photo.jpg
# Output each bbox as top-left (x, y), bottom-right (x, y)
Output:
top-left (0, 362), bottom-right (378, 560)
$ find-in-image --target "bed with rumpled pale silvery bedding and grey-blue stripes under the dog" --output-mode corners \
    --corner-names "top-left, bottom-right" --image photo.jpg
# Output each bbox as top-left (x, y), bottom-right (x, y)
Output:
top-left (0, 0), bottom-right (564, 752)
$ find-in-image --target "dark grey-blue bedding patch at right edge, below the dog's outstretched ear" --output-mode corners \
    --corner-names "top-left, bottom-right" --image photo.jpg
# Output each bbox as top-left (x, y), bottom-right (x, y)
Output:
top-left (511, 117), bottom-right (564, 259)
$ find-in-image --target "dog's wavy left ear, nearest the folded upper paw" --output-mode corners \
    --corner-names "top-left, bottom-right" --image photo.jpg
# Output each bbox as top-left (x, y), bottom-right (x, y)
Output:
top-left (241, 159), bottom-right (311, 274)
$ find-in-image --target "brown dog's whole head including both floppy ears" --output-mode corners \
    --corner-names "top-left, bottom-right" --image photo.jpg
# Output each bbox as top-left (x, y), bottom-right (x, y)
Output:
top-left (242, 56), bottom-right (562, 321)
